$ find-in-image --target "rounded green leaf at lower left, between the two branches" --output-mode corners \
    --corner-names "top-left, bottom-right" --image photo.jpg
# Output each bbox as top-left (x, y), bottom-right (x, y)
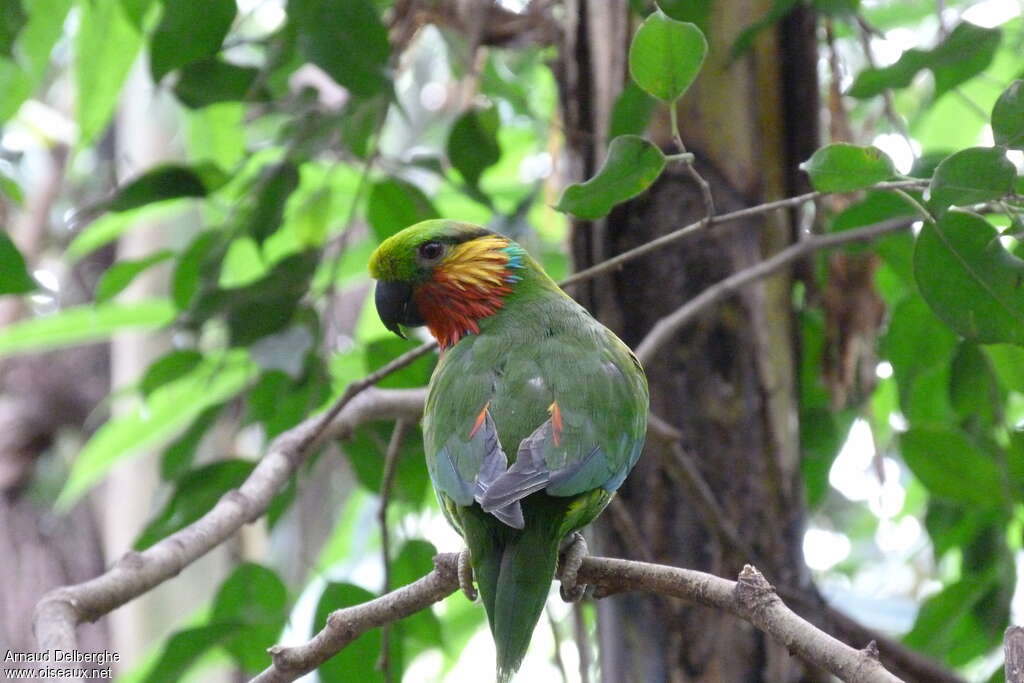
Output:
top-left (210, 562), bottom-right (288, 673)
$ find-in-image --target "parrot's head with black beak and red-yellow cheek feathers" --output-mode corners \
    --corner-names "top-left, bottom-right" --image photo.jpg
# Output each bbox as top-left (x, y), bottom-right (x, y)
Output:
top-left (370, 220), bottom-right (527, 348)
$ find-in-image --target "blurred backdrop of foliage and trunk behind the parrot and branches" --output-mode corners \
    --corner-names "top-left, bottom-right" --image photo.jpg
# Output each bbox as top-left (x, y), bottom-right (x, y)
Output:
top-left (0, 0), bottom-right (1024, 682)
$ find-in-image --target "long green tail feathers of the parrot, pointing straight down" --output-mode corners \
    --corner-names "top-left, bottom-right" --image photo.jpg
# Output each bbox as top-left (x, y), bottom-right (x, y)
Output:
top-left (463, 497), bottom-right (565, 683)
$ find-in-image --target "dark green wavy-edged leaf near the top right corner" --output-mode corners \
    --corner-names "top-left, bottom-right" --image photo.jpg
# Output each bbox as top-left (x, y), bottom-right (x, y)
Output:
top-left (847, 22), bottom-right (1002, 98)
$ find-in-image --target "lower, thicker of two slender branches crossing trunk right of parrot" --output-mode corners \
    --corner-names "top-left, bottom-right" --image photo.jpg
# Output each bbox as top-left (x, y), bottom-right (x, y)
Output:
top-left (636, 218), bottom-right (910, 366)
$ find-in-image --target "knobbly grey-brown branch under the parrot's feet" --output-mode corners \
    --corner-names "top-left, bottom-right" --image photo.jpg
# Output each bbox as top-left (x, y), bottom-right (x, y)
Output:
top-left (253, 553), bottom-right (900, 683)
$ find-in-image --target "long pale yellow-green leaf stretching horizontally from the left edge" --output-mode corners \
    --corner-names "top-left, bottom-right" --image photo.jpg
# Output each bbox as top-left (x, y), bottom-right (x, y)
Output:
top-left (0, 299), bottom-right (174, 357)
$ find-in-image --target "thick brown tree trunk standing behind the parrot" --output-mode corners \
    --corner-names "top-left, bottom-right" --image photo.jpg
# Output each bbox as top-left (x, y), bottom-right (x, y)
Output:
top-left (560, 0), bottom-right (817, 683)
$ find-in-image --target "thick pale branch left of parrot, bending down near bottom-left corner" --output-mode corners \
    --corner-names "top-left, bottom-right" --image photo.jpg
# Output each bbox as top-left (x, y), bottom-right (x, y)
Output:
top-left (34, 387), bottom-right (426, 650)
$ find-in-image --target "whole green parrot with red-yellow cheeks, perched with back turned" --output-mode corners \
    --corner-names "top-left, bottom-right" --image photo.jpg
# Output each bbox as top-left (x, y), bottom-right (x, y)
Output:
top-left (370, 220), bottom-right (648, 683)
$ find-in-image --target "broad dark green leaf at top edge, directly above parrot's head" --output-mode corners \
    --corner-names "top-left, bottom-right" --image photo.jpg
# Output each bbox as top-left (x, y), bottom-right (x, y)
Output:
top-left (288, 0), bottom-right (391, 96)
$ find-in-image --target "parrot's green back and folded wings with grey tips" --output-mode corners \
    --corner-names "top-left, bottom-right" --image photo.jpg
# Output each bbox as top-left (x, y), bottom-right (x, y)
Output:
top-left (425, 316), bottom-right (647, 528)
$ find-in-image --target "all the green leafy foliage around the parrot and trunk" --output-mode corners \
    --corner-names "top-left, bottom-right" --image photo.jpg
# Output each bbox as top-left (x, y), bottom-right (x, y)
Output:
top-left (0, 0), bottom-right (1024, 681)
